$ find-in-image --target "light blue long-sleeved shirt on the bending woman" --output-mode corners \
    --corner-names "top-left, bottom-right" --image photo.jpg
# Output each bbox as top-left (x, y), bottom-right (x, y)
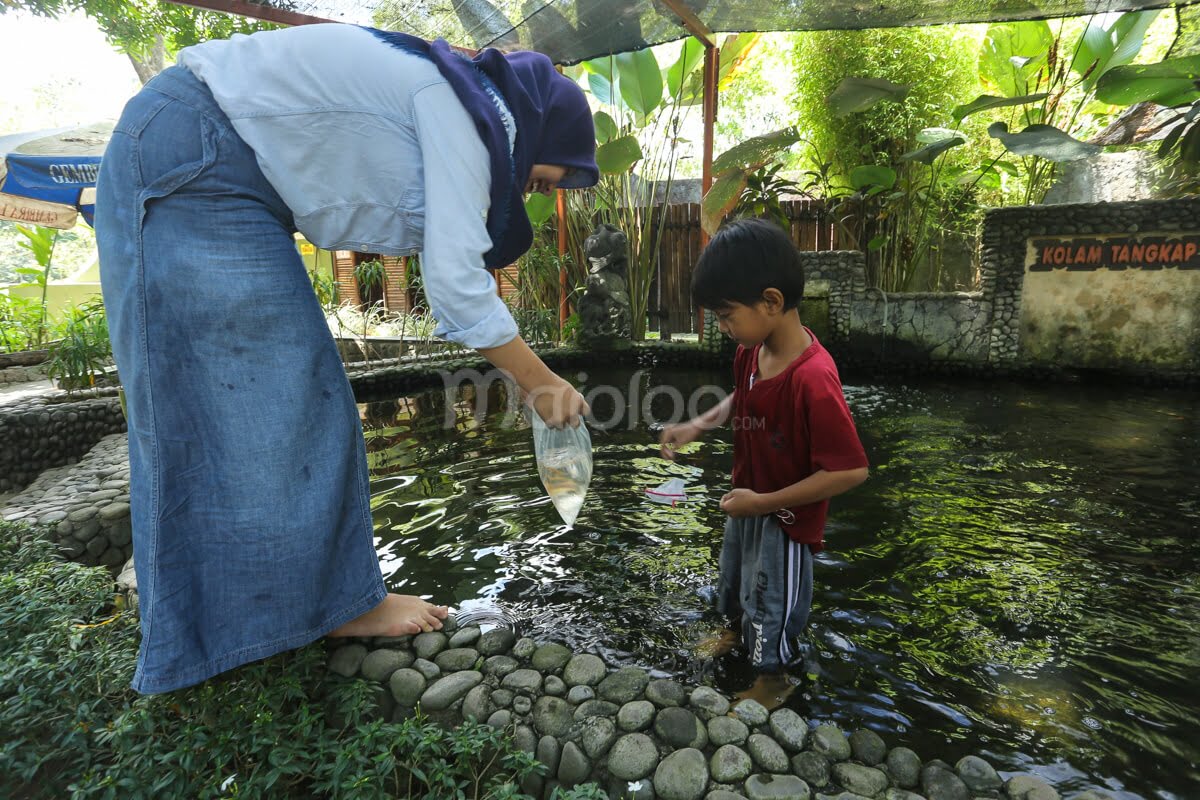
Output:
top-left (179, 24), bottom-right (517, 349)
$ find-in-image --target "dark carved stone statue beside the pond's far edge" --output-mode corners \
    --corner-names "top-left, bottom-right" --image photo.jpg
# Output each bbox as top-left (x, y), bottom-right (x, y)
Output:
top-left (578, 223), bottom-right (631, 347)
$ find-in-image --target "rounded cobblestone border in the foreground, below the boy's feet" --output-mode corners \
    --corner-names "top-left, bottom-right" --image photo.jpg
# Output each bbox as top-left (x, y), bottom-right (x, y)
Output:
top-left (329, 618), bottom-right (1112, 800)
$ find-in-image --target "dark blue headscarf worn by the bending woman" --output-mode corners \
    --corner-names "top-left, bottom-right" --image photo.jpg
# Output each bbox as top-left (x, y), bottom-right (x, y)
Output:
top-left (357, 28), bottom-right (600, 269)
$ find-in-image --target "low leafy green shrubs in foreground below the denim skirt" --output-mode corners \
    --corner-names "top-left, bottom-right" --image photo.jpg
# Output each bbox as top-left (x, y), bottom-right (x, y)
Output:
top-left (0, 522), bottom-right (598, 800)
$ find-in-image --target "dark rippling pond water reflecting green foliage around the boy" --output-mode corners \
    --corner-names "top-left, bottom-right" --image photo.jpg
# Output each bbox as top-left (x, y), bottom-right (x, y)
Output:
top-left (361, 369), bottom-right (1200, 800)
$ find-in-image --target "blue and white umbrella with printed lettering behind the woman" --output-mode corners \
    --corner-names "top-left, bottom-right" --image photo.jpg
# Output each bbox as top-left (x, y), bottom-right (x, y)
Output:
top-left (0, 122), bottom-right (113, 229)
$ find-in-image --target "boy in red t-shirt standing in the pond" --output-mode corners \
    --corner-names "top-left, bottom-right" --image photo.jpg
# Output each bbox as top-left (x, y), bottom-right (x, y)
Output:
top-left (660, 219), bottom-right (868, 699)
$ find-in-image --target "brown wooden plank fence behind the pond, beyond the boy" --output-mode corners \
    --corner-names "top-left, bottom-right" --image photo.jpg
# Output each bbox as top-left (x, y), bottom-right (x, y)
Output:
top-left (647, 199), bottom-right (838, 333)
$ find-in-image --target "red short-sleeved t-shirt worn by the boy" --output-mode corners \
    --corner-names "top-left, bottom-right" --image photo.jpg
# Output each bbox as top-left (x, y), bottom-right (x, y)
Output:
top-left (731, 329), bottom-right (868, 553)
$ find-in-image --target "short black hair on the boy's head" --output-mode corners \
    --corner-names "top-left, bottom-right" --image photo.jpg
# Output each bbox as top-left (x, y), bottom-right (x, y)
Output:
top-left (691, 219), bottom-right (804, 311)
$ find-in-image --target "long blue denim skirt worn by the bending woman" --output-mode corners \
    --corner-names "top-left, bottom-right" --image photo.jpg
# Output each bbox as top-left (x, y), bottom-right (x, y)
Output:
top-left (96, 67), bottom-right (386, 693)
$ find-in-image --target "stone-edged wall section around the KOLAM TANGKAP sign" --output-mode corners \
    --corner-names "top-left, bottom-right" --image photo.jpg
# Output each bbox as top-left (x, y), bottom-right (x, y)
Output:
top-left (980, 198), bottom-right (1200, 375)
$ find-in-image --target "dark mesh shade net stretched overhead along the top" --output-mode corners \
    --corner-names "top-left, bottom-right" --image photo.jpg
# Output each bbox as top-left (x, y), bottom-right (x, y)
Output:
top-left (244, 0), bottom-right (1200, 65)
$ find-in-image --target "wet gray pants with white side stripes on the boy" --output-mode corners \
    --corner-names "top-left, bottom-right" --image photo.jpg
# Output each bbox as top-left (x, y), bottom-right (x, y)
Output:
top-left (716, 515), bottom-right (812, 672)
